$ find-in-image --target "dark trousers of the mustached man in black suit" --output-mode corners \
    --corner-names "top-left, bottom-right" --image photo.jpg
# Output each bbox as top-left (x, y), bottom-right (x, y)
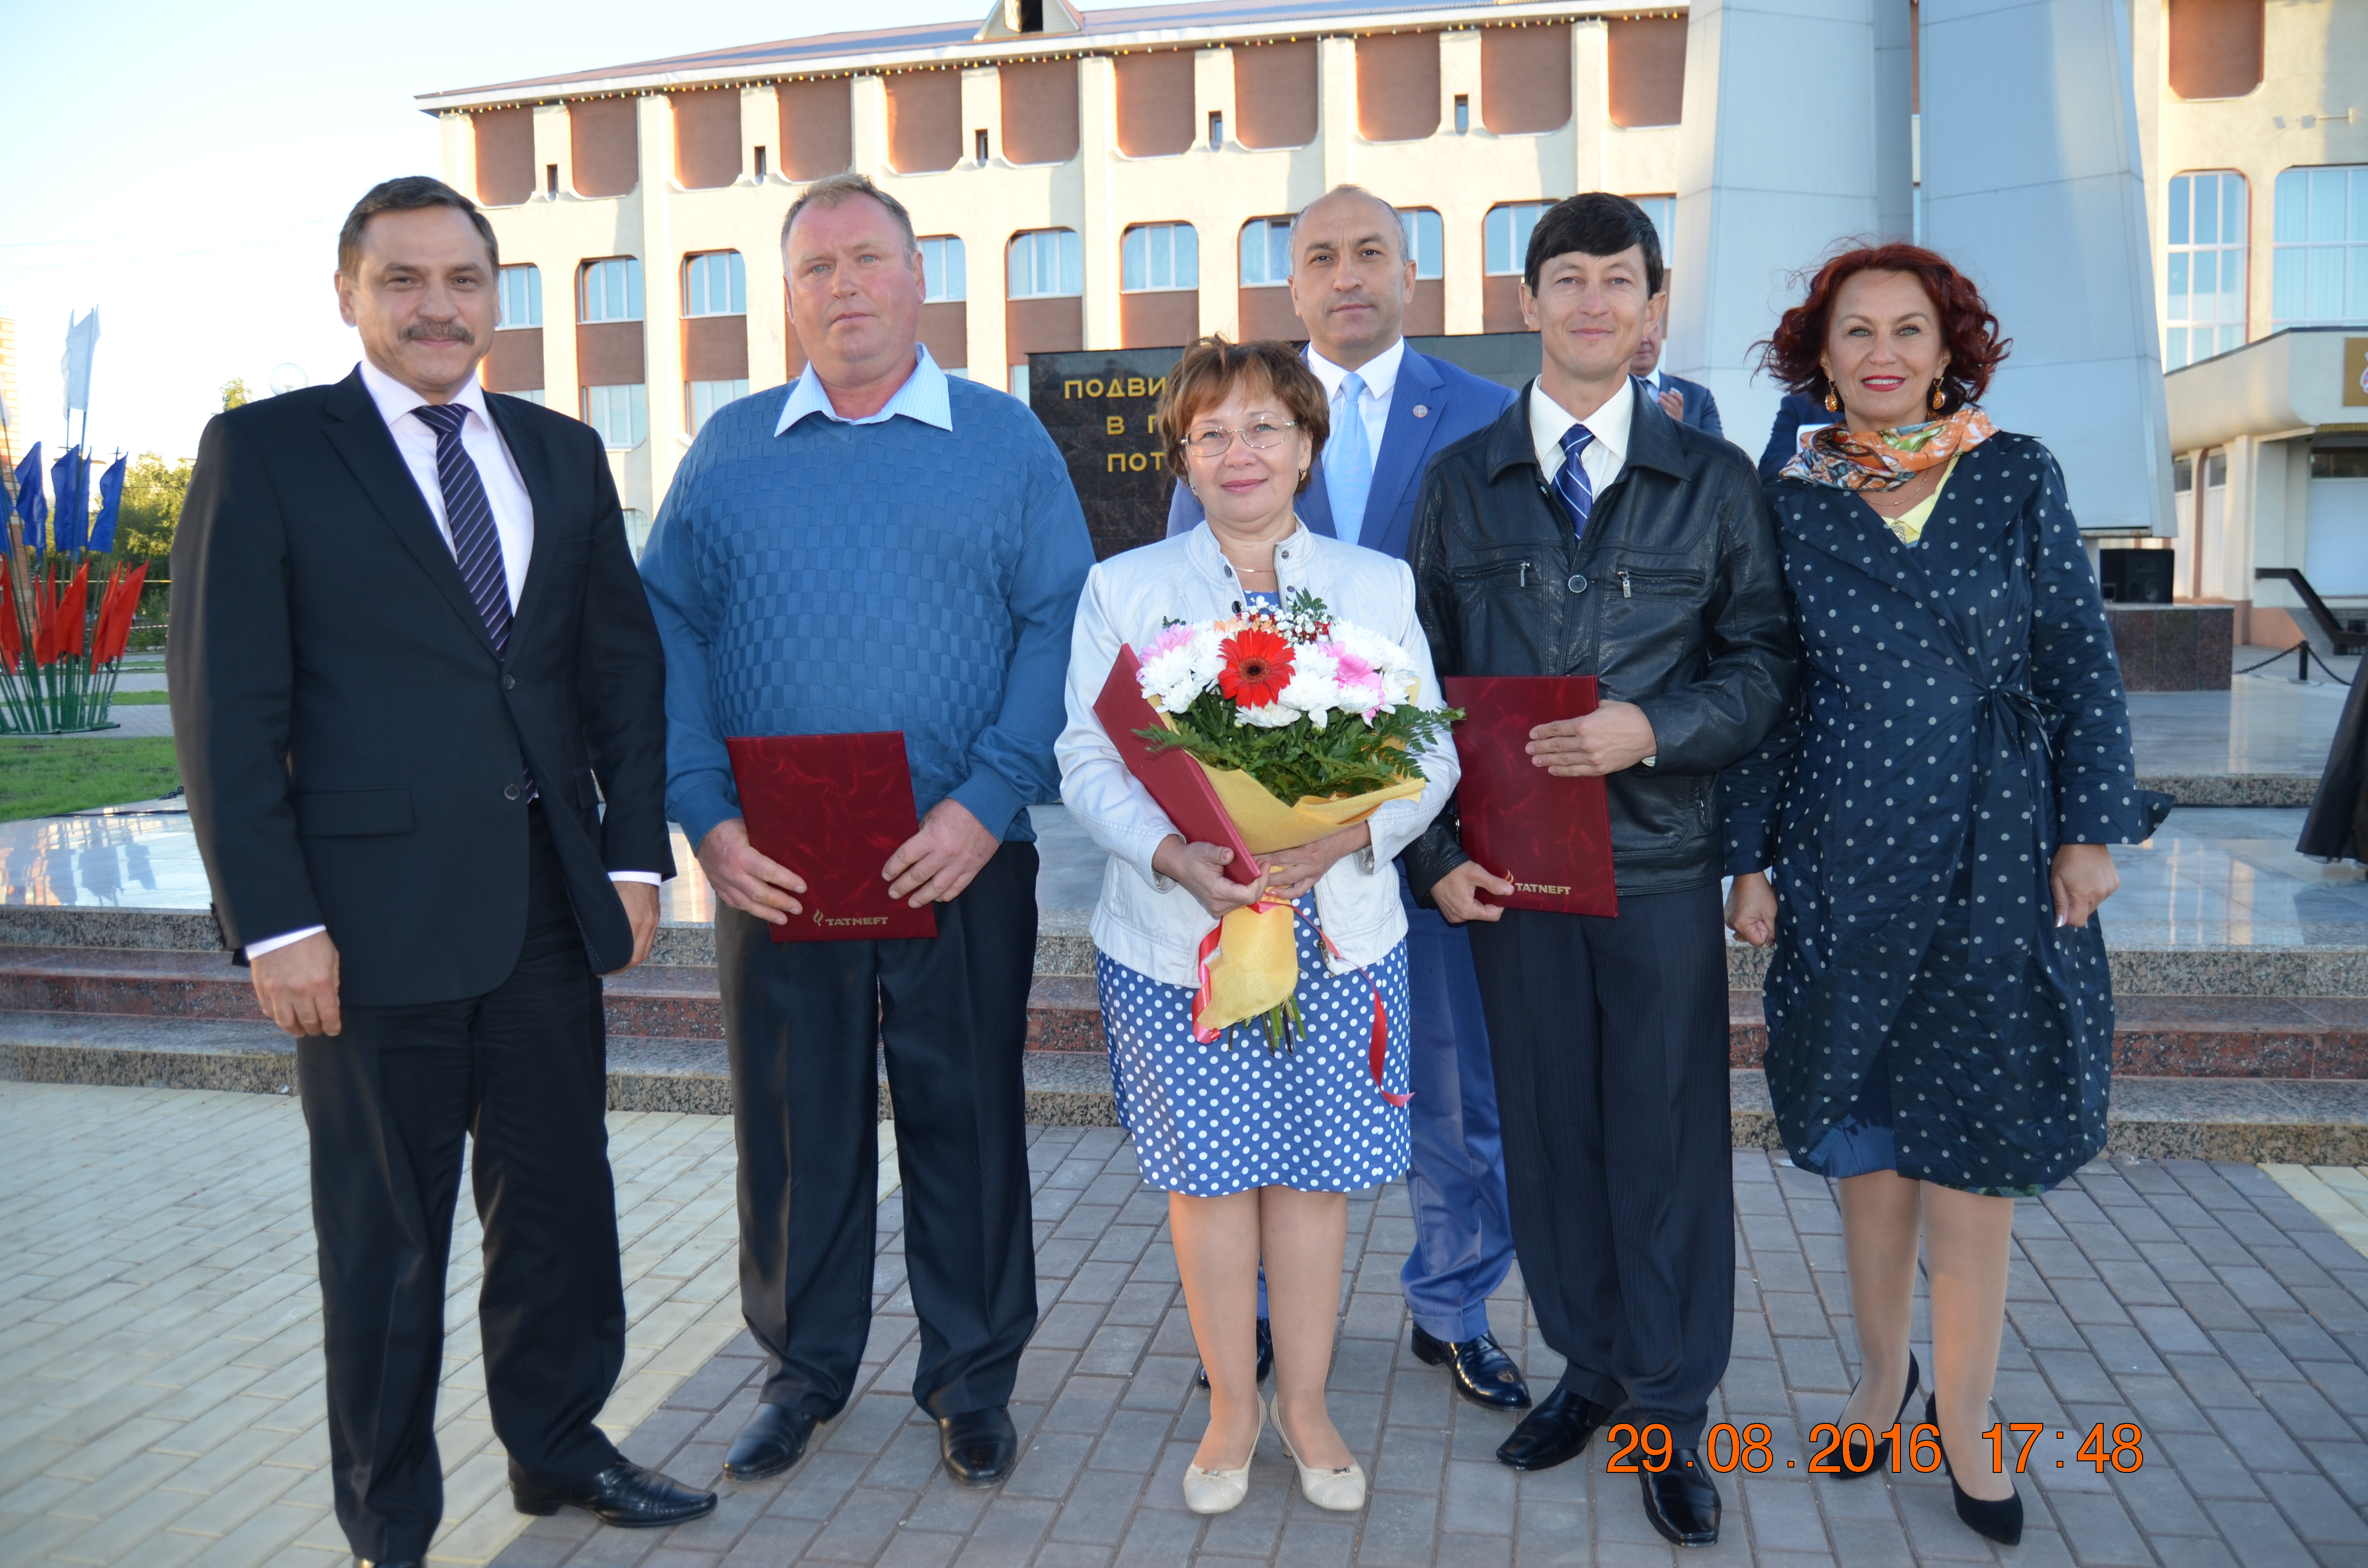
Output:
top-left (296, 808), bottom-right (625, 1561)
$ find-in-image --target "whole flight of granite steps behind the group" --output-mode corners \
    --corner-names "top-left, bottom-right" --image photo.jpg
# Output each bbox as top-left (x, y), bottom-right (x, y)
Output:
top-left (0, 907), bottom-right (2368, 1165)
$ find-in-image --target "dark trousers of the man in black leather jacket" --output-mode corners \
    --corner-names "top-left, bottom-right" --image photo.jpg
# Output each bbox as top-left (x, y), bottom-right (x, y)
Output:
top-left (1470, 883), bottom-right (1736, 1447)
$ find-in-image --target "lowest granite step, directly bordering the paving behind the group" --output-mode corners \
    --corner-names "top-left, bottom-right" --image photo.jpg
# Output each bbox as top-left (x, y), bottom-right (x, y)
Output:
top-left (0, 1011), bottom-right (2368, 1165)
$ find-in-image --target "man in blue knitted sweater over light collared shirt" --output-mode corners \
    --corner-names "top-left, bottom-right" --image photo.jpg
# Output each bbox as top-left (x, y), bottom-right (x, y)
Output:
top-left (641, 175), bottom-right (1094, 1485)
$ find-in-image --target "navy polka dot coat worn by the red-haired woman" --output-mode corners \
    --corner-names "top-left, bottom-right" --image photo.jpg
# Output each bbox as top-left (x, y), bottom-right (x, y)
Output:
top-left (1719, 433), bottom-right (2169, 1194)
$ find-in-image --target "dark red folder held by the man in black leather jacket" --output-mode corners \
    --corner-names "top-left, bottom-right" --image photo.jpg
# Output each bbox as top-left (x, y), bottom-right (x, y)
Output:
top-left (1440, 675), bottom-right (1620, 914)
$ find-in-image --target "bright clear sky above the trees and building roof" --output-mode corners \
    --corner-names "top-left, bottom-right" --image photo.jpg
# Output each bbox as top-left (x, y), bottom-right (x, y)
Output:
top-left (0, 0), bottom-right (987, 457)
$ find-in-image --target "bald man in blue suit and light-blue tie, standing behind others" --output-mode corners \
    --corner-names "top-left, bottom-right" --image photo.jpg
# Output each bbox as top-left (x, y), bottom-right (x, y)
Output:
top-left (1168, 185), bottom-right (1529, 1409)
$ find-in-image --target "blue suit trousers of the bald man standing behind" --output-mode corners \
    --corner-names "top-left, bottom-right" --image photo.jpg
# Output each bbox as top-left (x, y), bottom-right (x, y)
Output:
top-left (1399, 881), bottom-right (1513, 1341)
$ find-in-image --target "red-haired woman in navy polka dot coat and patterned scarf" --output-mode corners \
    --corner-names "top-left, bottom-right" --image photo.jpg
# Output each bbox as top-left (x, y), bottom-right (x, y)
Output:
top-left (1722, 246), bottom-right (2167, 1540)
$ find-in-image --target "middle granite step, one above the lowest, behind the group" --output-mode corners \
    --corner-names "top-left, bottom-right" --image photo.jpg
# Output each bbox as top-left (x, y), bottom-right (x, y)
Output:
top-left (0, 947), bottom-right (2368, 1080)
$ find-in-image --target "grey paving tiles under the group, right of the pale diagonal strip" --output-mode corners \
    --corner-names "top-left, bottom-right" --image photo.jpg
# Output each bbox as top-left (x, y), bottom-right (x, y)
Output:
top-left (495, 1127), bottom-right (2368, 1568)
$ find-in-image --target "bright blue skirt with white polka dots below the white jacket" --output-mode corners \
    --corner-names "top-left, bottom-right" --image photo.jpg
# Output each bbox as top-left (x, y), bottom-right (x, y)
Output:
top-left (1094, 893), bottom-right (1409, 1199)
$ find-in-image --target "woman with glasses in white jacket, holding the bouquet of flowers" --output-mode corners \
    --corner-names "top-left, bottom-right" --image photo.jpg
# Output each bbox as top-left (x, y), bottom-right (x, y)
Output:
top-left (1059, 339), bottom-right (1456, 1514)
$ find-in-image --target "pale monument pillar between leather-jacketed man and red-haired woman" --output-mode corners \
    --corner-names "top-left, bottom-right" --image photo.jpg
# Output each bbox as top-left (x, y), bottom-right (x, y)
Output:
top-left (1667, 0), bottom-right (1885, 464)
